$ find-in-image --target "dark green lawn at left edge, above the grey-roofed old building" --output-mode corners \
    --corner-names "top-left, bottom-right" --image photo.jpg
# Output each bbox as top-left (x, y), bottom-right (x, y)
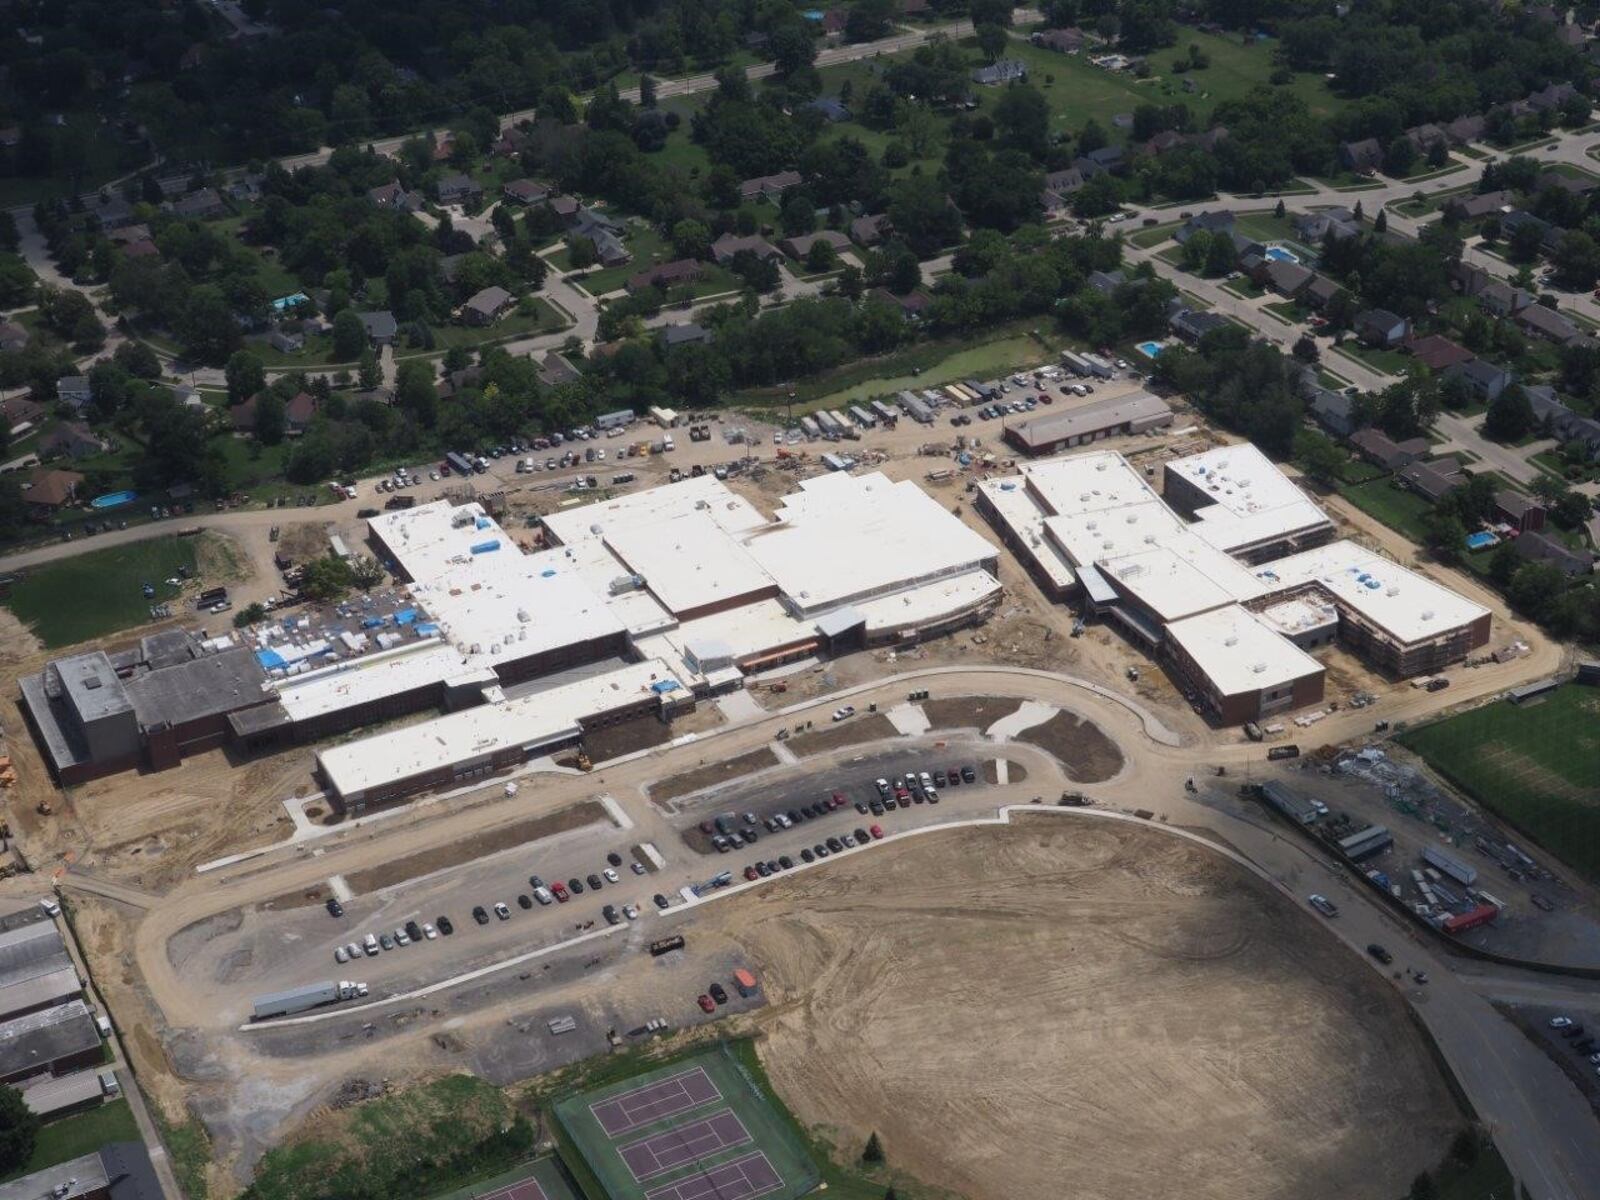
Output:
top-left (0, 536), bottom-right (195, 648)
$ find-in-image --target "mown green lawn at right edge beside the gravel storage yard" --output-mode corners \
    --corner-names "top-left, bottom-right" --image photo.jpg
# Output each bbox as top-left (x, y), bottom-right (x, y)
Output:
top-left (1400, 683), bottom-right (1600, 880)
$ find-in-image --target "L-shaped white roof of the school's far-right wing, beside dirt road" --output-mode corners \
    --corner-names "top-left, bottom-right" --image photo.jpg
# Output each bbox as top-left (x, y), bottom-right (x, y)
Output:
top-left (1254, 541), bottom-right (1488, 645)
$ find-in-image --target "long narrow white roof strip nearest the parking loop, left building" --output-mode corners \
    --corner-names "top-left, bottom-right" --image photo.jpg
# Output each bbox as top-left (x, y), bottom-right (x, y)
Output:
top-left (317, 659), bottom-right (682, 797)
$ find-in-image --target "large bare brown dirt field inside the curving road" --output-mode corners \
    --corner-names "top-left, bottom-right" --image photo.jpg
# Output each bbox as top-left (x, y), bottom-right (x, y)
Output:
top-left (694, 816), bottom-right (1462, 1200)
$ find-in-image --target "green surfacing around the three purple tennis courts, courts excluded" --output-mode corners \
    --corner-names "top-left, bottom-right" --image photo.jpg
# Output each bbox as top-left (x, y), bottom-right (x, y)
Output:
top-left (552, 1045), bottom-right (821, 1200)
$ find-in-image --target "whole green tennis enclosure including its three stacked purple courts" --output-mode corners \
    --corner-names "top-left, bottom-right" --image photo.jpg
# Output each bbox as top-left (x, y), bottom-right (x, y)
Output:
top-left (553, 1045), bottom-right (821, 1200)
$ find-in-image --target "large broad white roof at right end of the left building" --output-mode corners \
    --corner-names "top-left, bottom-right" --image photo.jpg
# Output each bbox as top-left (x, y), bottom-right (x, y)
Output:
top-left (746, 470), bottom-right (998, 616)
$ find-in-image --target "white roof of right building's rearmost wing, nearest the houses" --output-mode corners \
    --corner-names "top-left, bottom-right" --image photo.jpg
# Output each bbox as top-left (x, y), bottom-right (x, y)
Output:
top-left (1166, 442), bottom-right (1330, 552)
